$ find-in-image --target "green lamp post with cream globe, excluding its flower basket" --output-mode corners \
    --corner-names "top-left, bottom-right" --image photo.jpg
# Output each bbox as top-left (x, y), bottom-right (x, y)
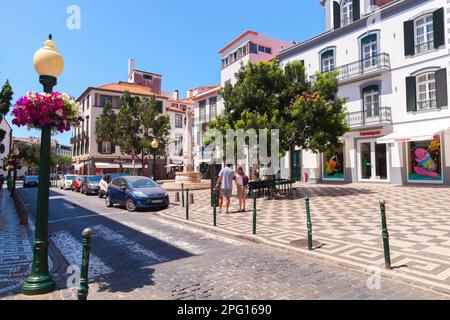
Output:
top-left (22, 35), bottom-right (64, 295)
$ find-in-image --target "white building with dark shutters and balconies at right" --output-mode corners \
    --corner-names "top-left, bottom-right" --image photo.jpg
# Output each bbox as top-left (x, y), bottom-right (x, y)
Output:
top-left (279, 0), bottom-right (450, 185)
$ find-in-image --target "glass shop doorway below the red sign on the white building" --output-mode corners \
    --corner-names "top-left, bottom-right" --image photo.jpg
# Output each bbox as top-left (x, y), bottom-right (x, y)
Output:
top-left (358, 140), bottom-right (390, 182)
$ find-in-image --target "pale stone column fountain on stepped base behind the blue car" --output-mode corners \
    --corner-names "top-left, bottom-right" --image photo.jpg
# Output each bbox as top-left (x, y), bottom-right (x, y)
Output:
top-left (164, 109), bottom-right (210, 190)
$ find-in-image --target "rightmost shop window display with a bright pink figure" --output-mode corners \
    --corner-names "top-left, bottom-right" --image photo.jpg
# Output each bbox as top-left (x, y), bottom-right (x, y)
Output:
top-left (409, 138), bottom-right (442, 181)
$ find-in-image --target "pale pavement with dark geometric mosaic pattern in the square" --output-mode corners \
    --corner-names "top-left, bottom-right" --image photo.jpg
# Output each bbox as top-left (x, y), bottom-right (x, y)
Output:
top-left (159, 184), bottom-right (450, 293)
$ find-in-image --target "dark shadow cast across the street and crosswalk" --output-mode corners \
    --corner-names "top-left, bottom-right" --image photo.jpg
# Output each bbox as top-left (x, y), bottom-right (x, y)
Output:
top-left (19, 190), bottom-right (194, 293)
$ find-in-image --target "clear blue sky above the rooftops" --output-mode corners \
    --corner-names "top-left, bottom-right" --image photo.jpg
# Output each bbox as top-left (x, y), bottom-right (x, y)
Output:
top-left (0, 0), bottom-right (325, 144)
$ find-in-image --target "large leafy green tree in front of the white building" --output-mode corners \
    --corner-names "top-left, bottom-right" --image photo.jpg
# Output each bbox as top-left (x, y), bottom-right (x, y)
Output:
top-left (204, 61), bottom-right (349, 172)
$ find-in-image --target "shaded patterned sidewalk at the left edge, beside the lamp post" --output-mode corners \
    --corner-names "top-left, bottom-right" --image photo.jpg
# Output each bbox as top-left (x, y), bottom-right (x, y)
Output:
top-left (0, 188), bottom-right (33, 297)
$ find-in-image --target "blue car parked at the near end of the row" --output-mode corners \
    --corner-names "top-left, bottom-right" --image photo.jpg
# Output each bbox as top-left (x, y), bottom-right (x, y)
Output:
top-left (105, 176), bottom-right (169, 212)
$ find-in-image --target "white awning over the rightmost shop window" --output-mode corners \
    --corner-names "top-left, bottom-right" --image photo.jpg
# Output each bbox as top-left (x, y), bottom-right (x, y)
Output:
top-left (377, 119), bottom-right (450, 144)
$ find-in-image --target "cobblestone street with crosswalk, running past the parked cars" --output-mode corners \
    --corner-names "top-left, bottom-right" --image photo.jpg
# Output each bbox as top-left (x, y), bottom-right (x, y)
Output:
top-left (2, 185), bottom-right (448, 300)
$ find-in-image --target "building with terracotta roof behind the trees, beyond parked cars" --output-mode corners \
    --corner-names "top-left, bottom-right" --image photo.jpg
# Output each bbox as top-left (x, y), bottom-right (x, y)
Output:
top-left (71, 60), bottom-right (188, 179)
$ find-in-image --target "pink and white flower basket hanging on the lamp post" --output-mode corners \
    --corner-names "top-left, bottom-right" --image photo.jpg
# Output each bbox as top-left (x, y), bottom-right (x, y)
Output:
top-left (12, 92), bottom-right (83, 133)
